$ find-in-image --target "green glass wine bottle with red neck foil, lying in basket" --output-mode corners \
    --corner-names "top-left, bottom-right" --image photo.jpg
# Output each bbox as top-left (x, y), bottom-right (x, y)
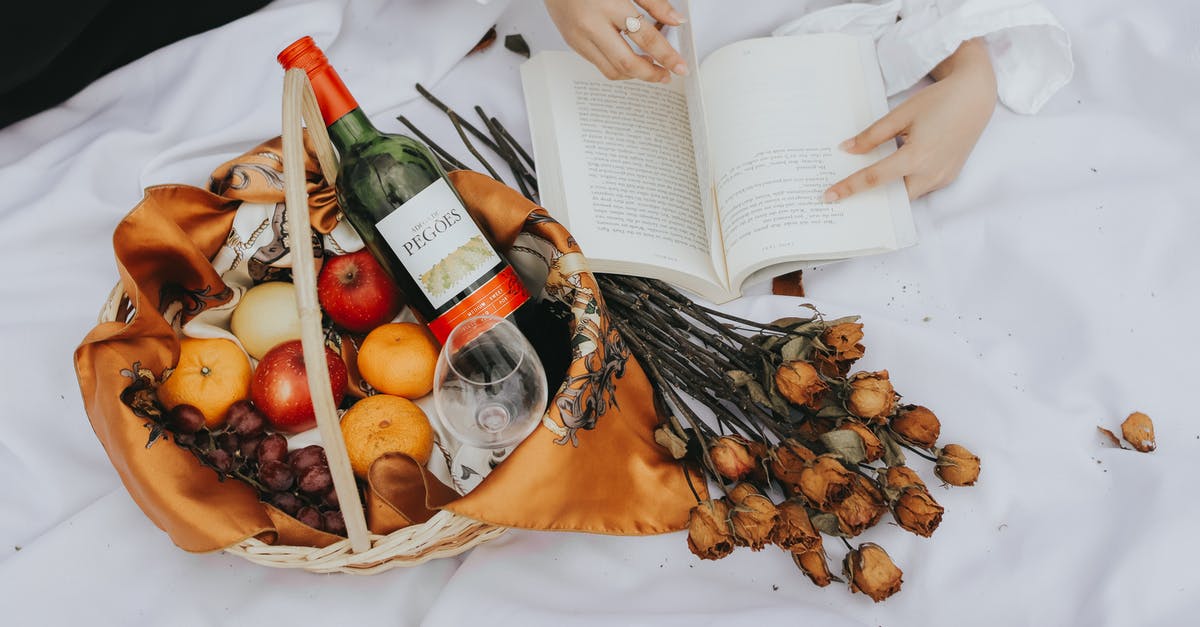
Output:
top-left (278, 37), bottom-right (542, 352)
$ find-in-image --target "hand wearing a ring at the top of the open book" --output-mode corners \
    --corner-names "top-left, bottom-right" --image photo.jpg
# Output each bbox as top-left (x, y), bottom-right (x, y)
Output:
top-left (546, 0), bottom-right (688, 83)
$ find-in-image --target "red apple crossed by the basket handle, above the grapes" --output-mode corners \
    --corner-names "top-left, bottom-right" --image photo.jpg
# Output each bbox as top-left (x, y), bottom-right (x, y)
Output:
top-left (250, 340), bottom-right (347, 434)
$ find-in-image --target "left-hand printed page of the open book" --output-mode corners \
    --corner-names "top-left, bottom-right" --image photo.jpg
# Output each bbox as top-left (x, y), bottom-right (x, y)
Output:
top-left (522, 52), bottom-right (724, 293)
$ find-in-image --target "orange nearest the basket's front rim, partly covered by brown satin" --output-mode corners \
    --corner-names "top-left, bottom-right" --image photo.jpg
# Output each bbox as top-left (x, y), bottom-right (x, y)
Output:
top-left (342, 394), bottom-right (433, 479)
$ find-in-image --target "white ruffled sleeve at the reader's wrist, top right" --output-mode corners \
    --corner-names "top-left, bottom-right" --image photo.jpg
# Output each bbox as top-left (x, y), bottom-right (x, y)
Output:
top-left (775, 0), bottom-right (1074, 114)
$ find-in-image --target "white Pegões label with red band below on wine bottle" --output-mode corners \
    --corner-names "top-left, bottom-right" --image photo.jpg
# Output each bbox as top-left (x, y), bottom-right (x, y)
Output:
top-left (376, 179), bottom-right (529, 341)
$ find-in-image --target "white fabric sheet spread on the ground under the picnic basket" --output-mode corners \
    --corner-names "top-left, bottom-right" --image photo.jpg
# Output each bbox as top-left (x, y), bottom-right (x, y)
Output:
top-left (0, 0), bottom-right (1200, 626)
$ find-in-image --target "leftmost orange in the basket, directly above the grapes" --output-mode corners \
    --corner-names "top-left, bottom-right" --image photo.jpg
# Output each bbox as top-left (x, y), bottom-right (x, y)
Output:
top-left (158, 338), bottom-right (252, 429)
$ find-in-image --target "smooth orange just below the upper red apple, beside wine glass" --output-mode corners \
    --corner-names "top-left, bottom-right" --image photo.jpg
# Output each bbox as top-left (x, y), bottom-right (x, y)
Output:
top-left (358, 322), bottom-right (438, 399)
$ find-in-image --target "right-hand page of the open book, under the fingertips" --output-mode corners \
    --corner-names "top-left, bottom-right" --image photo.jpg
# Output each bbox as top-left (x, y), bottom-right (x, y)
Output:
top-left (701, 34), bottom-right (911, 286)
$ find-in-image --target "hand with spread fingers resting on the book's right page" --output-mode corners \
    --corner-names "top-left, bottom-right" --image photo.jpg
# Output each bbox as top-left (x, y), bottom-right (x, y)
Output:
top-left (824, 40), bottom-right (996, 202)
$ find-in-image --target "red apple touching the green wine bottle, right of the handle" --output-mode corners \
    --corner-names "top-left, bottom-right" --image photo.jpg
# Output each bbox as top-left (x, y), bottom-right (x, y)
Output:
top-left (317, 249), bottom-right (404, 333)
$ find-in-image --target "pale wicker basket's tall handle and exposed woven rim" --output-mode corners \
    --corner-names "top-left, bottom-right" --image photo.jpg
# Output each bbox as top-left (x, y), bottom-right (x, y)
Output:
top-left (93, 70), bottom-right (506, 574)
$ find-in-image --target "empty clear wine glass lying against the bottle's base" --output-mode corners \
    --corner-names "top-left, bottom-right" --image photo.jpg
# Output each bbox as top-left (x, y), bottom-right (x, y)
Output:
top-left (433, 316), bottom-right (547, 484)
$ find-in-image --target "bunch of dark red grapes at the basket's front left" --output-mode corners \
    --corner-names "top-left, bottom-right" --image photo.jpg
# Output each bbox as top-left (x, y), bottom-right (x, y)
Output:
top-left (166, 400), bottom-right (346, 536)
